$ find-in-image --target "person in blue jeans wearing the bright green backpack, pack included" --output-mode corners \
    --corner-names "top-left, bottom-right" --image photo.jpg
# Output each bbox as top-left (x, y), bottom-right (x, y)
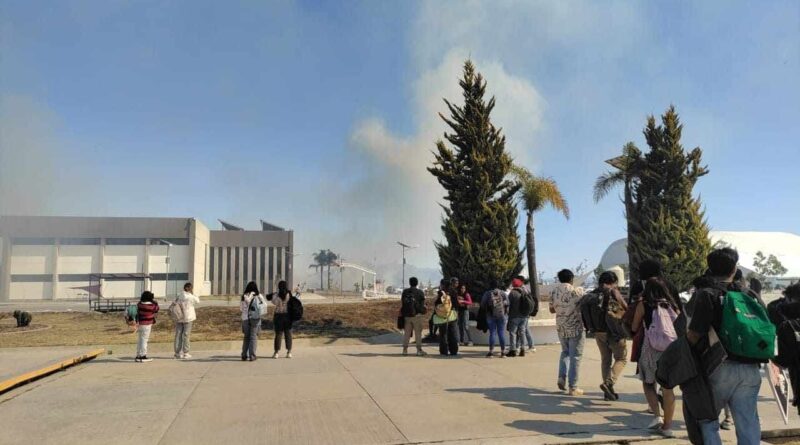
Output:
top-left (687, 247), bottom-right (775, 445)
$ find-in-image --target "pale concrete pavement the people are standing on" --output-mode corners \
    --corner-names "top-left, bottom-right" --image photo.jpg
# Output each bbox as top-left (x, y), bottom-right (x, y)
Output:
top-left (0, 342), bottom-right (800, 444)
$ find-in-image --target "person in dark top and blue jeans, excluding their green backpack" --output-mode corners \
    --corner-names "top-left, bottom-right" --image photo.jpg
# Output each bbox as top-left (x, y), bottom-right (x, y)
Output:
top-left (687, 247), bottom-right (765, 445)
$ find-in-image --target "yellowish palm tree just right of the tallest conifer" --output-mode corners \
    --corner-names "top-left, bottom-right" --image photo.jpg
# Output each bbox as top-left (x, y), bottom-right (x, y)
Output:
top-left (511, 165), bottom-right (569, 300)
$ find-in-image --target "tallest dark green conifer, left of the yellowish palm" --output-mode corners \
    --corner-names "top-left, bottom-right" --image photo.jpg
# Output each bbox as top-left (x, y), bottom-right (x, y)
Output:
top-left (428, 60), bottom-right (522, 295)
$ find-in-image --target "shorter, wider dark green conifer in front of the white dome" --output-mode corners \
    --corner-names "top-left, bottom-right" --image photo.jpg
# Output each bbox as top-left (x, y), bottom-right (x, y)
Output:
top-left (628, 106), bottom-right (711, 290)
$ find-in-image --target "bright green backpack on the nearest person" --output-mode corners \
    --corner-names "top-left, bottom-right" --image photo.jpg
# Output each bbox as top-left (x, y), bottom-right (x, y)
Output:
top-left (719, 291), bottom-right (775, 360)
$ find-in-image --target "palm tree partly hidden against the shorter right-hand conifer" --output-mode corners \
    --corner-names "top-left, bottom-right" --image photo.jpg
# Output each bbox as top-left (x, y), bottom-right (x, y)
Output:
top-left (594, 142), bottom-right (644, 283)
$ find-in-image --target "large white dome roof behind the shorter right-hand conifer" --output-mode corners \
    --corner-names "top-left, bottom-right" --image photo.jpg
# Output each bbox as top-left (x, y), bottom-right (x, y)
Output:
top-left (600, 231), bottom-right (800, 278)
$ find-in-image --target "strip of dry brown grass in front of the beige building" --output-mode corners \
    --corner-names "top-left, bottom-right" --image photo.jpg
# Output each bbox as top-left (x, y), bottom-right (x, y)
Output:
top-left (0, 301), bottom-right (399, 347)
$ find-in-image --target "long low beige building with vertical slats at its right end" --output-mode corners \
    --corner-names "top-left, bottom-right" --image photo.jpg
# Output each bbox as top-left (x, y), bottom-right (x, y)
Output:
top-left (0, 216), bottom-right (294, 301)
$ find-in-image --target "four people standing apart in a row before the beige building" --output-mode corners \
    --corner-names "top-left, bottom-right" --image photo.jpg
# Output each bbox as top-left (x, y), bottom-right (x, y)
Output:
top-left (131, 281), bottom-right (302, 363)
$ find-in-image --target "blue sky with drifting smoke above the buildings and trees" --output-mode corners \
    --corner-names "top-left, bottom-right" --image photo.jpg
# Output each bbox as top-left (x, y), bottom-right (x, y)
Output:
top-left (0, 0), bottom-right (800, 282)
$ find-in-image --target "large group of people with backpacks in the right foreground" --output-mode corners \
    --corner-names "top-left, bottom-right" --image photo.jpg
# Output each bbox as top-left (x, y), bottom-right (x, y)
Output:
top-left (550, 248), bottom-right (800, 445)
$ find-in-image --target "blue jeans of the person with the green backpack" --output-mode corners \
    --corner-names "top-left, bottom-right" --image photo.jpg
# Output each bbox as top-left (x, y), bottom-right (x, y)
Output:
top-left (700, 360), bottom-right (761, 445)
